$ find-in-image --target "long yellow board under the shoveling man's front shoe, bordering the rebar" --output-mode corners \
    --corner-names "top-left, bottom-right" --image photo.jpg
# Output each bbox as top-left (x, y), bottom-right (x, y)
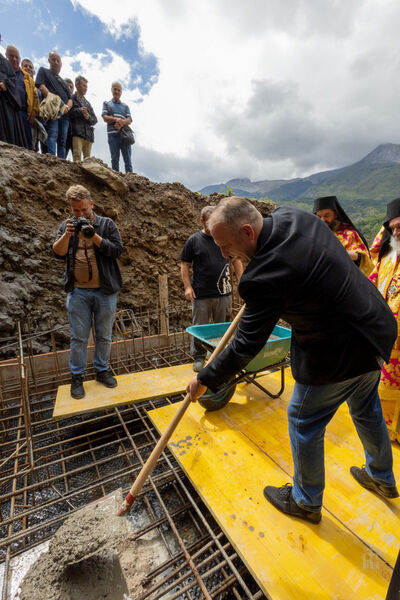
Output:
top-left (149, 398), bottom-right (392, 600)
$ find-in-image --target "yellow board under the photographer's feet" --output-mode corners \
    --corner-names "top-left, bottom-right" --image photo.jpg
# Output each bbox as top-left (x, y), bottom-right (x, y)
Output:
top-left (53, 364), bottom-right (193, 418)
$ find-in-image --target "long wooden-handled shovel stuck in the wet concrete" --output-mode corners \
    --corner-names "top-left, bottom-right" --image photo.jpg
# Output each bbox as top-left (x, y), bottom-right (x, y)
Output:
top-left (117, 305), bottom-right (245, 517)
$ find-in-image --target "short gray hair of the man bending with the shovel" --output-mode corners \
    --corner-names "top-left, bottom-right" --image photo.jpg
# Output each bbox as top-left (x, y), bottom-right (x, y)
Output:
top-left (209, 196), bottom-right (263, 229)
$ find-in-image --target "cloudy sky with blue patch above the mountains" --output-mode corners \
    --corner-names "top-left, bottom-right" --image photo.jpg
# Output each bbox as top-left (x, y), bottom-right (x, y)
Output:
top-left (0, 0), bottom-right (400, 190)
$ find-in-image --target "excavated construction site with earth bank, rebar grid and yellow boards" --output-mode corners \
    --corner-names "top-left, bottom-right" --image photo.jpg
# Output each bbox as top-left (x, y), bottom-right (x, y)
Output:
top-left (0, 144), bottom-right (400, 600)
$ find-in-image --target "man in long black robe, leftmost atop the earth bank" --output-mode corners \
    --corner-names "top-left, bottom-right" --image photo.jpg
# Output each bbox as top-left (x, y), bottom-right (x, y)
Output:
top-left (0, 54), bottom-right (26, 146)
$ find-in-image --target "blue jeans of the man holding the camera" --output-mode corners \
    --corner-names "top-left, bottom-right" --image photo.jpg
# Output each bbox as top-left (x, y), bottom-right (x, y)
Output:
top-left (67, 288), bottom-right (118, 375)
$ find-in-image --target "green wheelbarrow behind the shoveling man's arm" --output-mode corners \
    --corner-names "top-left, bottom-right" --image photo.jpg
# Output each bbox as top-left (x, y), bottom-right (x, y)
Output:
top-left (186, 323), bottom-right (292, 411)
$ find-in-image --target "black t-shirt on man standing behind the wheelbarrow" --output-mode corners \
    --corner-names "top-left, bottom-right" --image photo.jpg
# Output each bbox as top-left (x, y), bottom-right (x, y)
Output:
top-left (179, 231), bottom-right (232, 298)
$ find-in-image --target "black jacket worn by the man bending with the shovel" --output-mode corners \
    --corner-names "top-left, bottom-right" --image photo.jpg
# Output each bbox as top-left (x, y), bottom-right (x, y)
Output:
top-left (198, 206), bottom-right (397, 390)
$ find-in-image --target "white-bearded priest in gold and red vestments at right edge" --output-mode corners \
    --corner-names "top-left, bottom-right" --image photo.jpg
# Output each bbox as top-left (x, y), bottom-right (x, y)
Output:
top-left (370, 198), bottom-right (400, 441)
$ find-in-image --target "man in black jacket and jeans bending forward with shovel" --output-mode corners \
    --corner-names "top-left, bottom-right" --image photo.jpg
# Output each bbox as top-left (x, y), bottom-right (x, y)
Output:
top-left (187, 197), bottom-right (399, 523)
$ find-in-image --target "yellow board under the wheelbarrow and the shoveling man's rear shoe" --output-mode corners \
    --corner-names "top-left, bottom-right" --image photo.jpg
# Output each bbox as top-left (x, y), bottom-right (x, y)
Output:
top-left (223, 374), bottom-right (400, 567)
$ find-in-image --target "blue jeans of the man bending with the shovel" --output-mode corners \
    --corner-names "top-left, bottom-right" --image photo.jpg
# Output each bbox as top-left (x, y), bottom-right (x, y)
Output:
top-left (288, 371), bottom-right (395, 511)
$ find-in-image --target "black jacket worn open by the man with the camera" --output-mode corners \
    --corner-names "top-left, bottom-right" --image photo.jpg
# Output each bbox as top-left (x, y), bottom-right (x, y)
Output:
top-left (53, 215), bottom-right (123, 294)
